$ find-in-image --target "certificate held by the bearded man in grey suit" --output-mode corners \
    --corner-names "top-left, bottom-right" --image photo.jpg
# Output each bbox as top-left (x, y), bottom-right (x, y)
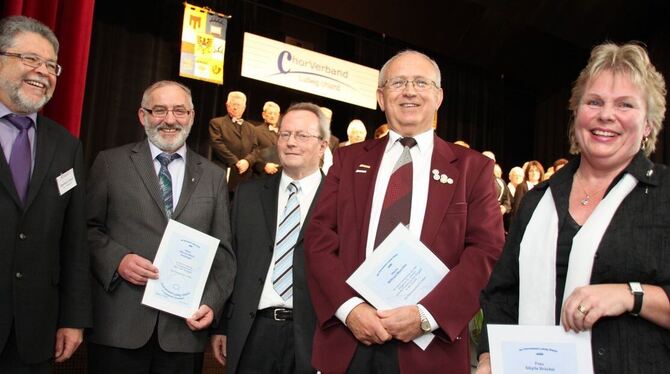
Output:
top-left (142, 220), bottom-right (219, 318)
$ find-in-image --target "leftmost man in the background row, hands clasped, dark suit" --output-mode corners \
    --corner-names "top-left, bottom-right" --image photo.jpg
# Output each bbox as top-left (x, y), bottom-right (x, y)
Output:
top-left (209, 91), bottom-right (258, 192)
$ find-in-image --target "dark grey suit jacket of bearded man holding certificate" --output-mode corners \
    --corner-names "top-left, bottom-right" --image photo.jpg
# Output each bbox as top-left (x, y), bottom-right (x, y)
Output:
top-left (86, 140), bottom-right (235, 352)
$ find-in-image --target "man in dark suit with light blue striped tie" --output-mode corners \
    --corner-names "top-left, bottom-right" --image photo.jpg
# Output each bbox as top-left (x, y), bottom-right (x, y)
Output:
top-left (212, 103), bottom-right (329, 374)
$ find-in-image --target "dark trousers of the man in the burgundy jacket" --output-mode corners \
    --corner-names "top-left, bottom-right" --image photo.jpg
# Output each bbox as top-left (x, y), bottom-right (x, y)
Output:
top-left (347, 340), bottom-right (400, 374)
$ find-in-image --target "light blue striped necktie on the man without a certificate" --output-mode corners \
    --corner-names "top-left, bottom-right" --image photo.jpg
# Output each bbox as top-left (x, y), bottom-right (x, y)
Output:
top-left (272, 182), bottom-right (300, 300)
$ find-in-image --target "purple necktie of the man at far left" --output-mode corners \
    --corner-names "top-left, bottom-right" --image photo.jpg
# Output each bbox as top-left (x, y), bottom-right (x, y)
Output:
top-left (4, 114), bottom-right (33, 204)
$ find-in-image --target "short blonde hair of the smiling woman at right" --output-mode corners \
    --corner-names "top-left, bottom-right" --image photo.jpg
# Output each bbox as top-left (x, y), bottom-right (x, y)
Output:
top-left (568, 42), bottom-right (667, 156)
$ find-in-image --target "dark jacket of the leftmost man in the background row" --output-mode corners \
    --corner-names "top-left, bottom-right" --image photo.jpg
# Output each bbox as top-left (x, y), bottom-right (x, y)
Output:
top-left (209, 115), bottom-right (258, 191)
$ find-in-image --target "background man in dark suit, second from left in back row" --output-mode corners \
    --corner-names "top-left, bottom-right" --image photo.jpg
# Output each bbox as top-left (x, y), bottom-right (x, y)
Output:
top-left (254, 101), bottom-right (281, 176)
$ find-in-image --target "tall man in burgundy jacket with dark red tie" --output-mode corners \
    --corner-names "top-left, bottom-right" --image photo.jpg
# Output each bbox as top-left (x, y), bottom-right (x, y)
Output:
top-left (305, 51), bottom-right (503, 374)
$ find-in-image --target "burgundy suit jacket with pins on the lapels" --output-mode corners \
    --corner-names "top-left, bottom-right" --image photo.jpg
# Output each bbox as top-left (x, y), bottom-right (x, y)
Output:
top-left (305, 136), bottom-right (504, 374)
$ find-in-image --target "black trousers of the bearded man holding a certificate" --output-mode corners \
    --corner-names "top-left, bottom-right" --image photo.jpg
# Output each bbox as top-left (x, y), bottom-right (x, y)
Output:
top-left (88, 330), bottom-right (204, 374)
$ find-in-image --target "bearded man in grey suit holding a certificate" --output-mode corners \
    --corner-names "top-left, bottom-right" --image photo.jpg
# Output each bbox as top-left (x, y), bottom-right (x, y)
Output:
top-left (86, 81), bottom-right (235, 374)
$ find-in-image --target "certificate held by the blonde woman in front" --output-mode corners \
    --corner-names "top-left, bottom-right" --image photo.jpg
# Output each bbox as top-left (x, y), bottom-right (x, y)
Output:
top-left (487, 325), bottom-right (593, 374)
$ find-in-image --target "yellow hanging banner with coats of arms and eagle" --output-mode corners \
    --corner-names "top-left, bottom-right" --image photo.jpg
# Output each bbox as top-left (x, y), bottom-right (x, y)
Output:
top-left (179, 3), bottom-right (230, 84)
